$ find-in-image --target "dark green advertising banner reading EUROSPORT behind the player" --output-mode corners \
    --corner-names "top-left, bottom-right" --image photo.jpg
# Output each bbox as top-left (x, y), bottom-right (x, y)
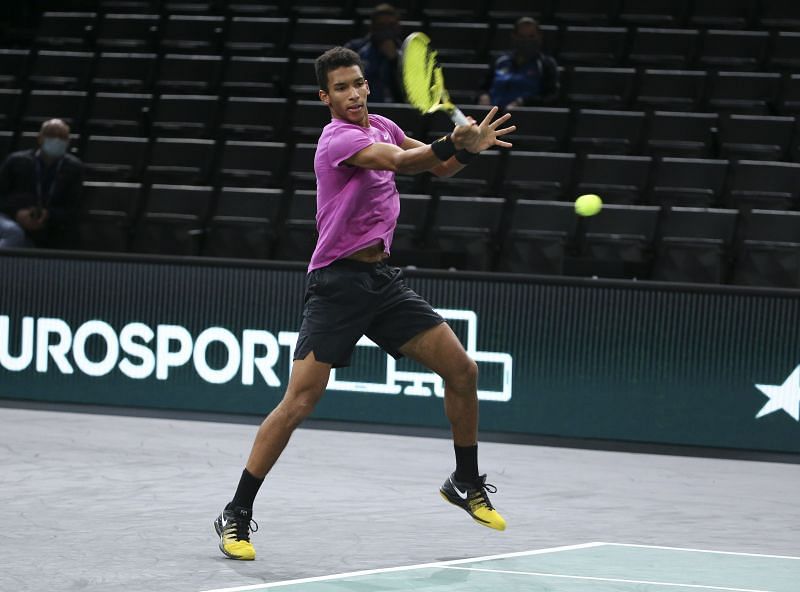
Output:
top-left (0, 252), bottom-right (800, 452)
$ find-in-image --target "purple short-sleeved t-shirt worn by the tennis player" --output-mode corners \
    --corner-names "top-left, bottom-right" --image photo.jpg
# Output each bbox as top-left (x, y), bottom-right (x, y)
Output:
top-left (308, 115), bottom-right (406, 272)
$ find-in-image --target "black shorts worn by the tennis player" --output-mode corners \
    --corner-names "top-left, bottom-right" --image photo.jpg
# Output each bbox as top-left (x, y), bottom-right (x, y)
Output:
top-left (294, 259), bottom-right (444, 368)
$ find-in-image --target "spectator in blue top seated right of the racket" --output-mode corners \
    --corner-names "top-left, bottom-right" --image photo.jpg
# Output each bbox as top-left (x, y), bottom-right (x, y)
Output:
top-left (478, 16), bottom-right (559, 111)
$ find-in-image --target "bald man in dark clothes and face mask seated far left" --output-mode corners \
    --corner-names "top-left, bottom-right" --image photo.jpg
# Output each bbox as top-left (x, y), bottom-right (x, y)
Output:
top-left (0, 119), bottom-right (83, 248)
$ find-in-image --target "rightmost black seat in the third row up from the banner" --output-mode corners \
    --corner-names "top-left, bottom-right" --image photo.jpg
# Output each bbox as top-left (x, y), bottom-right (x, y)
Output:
top-left (719, 114), bottom-right (795, 160)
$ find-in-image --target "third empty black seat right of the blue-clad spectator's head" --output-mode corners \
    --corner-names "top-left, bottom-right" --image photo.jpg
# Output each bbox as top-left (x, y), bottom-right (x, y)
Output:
top-left (697, 29), bottom-right (769, 71)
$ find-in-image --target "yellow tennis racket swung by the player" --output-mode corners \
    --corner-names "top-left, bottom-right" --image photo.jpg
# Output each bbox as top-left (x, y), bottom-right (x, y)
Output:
top-left (400, 31), bottom-right (470, 125)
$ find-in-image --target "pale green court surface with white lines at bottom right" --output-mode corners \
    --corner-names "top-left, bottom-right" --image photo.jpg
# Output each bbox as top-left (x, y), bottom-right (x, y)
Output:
top-left (206, 543), bottom-right (800, 592)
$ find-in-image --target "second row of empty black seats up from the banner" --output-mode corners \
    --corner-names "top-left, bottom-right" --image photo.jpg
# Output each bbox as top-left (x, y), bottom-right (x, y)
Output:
top-left (6, 121), bottom-right (800, 210)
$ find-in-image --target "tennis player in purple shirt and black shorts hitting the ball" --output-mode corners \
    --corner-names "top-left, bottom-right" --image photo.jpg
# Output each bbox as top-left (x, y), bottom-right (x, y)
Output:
top-left (214, 47), bottom-right (515, 560)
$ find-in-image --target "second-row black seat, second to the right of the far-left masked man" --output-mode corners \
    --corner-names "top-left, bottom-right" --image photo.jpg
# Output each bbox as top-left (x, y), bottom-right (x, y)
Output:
top-left (145, 138), bottom-right (214, 185)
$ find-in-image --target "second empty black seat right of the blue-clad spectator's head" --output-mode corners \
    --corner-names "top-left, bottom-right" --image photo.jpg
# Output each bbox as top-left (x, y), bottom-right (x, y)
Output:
top-left (627, 27), bottom-right (700, 69)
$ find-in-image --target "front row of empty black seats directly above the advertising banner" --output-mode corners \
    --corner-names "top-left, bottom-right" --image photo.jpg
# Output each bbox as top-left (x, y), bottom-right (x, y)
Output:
top-left (76, 182), bottom-right (800, 287)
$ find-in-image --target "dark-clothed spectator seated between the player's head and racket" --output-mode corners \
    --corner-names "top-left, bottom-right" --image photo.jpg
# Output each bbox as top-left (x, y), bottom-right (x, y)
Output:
top-left (345, 4), bottom-right (404, 103)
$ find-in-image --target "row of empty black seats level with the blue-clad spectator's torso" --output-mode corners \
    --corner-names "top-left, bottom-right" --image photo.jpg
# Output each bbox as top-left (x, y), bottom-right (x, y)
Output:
top-left (6, 50), bottom-right (800, 114)
